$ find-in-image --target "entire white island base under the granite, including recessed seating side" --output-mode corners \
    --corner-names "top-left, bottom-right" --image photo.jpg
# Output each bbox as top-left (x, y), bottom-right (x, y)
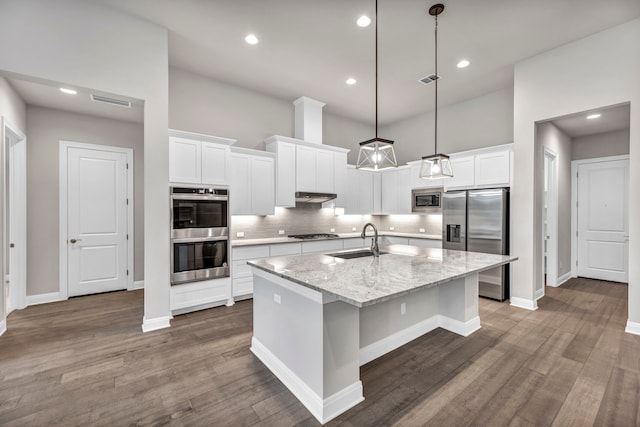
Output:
top-left (251, 268), bottom-right (480, 424)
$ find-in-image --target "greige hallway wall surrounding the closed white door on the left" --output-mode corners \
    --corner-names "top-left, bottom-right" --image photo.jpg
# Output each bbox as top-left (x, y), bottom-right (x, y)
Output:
top-left (27, 106), bottom-right (144, 295)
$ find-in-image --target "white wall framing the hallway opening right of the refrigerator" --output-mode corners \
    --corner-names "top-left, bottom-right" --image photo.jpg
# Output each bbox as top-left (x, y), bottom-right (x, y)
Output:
top-left (511, 20), bottom-right (640, 326)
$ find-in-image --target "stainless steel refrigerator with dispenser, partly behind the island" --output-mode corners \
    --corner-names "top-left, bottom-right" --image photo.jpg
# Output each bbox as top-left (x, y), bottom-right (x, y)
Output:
top-left (442, 188), bottom-right (509, 301)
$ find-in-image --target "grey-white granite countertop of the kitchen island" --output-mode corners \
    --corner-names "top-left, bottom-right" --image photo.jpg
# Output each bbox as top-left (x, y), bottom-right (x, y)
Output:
top-left (248, 245), bottom-right (518, 307)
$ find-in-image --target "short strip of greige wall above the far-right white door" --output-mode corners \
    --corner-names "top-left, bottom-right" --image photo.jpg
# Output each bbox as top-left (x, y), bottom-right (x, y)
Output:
top-left (571, 129), bottom-right (629, 160)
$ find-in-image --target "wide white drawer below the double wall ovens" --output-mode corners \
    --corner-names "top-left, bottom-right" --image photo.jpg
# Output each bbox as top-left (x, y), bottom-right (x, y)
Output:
top-left (170, 277), bottom-right (233, 315)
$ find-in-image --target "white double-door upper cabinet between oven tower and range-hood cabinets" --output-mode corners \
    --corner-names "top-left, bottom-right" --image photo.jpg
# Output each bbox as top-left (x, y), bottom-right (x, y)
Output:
top-left (229, 148), bottom-right (276, 215)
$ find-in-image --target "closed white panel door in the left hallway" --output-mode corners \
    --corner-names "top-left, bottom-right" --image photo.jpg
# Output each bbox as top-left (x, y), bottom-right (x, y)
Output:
top-left (66, 147), bottom-right (128, 297)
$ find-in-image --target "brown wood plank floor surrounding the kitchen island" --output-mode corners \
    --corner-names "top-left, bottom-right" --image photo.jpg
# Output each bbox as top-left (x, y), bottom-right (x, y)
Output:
top-left (0, 279), bottom-right (640, 426)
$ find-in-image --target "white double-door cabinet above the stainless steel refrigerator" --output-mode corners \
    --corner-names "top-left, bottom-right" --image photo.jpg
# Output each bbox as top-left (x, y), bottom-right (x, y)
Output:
top-left (444, 144), bottom-right (513, 191)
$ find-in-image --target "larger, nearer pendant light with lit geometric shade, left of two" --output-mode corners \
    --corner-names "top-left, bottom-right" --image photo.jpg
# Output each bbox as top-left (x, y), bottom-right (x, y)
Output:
top-left (356, 0), bottom-right (398, 170)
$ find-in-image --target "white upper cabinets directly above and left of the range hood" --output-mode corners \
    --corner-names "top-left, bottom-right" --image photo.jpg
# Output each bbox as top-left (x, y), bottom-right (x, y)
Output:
top-left (264, 135), bottom-right (349, 207)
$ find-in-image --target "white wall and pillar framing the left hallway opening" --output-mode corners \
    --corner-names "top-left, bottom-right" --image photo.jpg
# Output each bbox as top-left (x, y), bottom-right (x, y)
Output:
top-left (0, 0), bottom-right (170, 330)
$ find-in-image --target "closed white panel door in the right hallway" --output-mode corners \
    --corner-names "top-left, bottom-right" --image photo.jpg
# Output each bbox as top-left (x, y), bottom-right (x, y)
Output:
top-left (578, 160), bottom-right (629, 282)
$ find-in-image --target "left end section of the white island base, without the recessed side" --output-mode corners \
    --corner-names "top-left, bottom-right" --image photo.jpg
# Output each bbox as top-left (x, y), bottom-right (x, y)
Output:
top-left (251, 270), bottom-right (364, 423)
